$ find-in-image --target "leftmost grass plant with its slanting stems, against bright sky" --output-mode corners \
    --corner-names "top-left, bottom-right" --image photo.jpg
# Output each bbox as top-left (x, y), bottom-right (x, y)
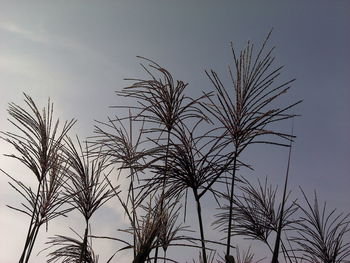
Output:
top-left (3, 94), bottom-right (75, 262)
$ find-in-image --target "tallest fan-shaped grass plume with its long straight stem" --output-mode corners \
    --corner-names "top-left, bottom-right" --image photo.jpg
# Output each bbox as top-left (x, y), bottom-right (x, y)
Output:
top-left (203, 30), bottom-right (300, 255)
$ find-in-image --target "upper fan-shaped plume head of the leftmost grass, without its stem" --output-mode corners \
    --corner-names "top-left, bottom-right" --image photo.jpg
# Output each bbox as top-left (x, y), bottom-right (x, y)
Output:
top-left (2, 94), bottom-right (75, 182)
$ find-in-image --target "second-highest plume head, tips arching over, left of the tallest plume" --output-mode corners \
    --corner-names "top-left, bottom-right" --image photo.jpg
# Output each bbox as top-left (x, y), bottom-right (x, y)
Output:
top-left (116, 57), bottom-right (208, 132)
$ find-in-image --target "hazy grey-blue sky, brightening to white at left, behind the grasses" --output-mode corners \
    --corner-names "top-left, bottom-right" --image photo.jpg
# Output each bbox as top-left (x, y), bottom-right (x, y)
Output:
top-left (0, 0), bottom-right (350, 263)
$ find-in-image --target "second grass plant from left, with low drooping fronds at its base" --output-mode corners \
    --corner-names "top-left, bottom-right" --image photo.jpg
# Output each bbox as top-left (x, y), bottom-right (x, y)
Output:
top-left (49, 137), bottom-right (119, 263)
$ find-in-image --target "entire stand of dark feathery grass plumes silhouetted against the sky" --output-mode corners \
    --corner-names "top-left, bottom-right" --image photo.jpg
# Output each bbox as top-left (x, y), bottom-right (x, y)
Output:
top-left (4, 31), bottom-right (350, 263)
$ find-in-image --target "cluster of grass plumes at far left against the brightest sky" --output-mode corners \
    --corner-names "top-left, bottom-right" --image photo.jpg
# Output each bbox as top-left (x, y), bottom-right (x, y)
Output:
top-left (3, 94), bottom-right (118, 262)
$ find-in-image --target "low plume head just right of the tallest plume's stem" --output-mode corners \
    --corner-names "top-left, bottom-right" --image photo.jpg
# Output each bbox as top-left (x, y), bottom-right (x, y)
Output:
top-left (214, 178), bottom-right (298, 260)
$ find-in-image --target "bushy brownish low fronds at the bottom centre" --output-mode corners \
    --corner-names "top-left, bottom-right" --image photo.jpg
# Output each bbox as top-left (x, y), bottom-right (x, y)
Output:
top-left (103, 191), bottom-right (191, 263)
